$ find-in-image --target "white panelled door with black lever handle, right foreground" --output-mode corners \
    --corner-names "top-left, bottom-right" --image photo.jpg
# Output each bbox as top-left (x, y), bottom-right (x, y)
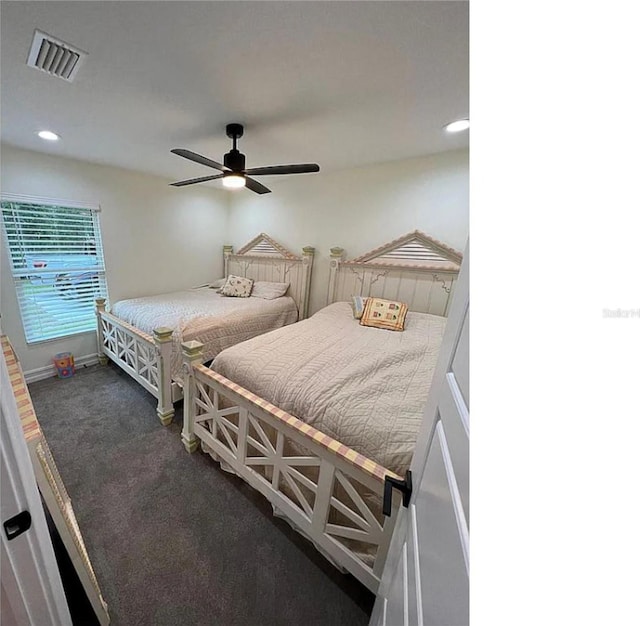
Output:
top-left (370, 245), bottom-right (469, 626)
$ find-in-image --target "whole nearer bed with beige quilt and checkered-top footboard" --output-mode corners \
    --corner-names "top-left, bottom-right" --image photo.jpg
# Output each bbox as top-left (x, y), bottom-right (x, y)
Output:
top-left (182, 232), bottom-right (461, 592)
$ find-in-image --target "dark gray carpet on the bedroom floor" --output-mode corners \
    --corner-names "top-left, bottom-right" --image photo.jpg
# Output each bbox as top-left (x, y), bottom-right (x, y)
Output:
top-left (29, 365), bottom-right (374, 626)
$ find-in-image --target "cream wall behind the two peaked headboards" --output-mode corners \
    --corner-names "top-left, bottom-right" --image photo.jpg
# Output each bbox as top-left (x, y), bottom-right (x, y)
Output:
top-left (228, 150), bottom-right (469, 313)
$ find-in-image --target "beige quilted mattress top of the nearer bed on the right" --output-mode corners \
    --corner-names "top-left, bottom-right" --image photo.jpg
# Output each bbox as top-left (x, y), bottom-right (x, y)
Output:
top-left (211, 302), bottom-right (446, 474)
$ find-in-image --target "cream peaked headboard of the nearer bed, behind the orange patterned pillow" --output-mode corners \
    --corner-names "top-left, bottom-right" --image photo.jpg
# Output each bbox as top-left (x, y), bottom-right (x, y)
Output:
top-left (327, 230), bottom-right (462, 315)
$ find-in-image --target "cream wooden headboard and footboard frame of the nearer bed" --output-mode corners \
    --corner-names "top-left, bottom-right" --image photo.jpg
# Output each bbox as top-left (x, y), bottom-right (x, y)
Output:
top-left (182, 231), bottom-right (462, 593)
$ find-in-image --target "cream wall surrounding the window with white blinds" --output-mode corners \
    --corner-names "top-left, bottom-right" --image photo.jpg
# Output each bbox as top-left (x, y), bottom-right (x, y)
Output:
top-left (0, 145), bottom-right (228, 372)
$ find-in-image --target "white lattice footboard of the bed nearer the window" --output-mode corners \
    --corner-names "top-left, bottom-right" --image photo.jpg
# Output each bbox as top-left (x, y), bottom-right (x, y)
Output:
top-left (96, 298), bottom-right (179, 426)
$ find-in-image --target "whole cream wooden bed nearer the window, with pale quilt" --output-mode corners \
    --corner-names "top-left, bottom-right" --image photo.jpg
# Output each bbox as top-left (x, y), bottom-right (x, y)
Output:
top-left (96, 233), bottom-right (314, 426)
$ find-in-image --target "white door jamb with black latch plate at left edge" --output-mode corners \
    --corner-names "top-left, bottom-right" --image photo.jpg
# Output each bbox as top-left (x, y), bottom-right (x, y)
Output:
top-left (0, 344), bottom-right (71, 626)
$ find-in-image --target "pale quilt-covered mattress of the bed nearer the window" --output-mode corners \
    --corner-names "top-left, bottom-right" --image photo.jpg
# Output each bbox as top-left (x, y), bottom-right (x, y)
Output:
top-left (111, 287), bottom-right (298, 381)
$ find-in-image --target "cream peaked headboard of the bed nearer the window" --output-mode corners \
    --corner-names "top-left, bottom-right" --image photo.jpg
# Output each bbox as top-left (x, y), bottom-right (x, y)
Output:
top-left (223, 233), bottom-right (315, 319)
